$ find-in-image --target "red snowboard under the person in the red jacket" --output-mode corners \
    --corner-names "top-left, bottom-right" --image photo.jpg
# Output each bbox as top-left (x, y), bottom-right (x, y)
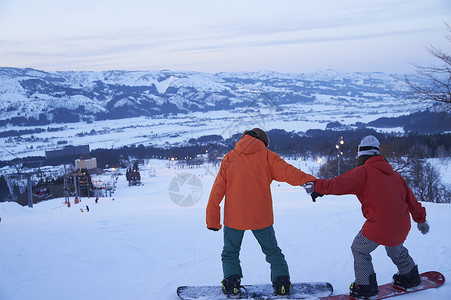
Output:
top-left (319, 271), bottom-right (445, 300)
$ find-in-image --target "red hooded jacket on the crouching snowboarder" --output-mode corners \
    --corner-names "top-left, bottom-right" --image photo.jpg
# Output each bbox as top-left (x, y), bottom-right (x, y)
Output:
top-left (315, 156), bottom-right (426, 247)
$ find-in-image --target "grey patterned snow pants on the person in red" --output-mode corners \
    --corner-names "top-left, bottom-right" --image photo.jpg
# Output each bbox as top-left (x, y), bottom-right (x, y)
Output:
top-left (351, 231), bottom-right (415, 285)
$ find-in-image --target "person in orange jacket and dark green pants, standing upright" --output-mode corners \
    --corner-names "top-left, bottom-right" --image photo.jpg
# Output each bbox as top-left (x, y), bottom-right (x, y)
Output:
top-left (206, 128), bottom-right (316, 296)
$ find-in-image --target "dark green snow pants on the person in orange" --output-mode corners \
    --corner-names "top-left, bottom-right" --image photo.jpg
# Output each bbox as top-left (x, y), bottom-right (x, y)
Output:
top-left (221, 225), bottom-right (290, 282)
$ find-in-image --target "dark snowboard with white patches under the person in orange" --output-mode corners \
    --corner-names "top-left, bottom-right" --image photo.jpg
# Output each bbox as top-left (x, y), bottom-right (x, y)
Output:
top-left (177, 282), bottom-right (333, 300)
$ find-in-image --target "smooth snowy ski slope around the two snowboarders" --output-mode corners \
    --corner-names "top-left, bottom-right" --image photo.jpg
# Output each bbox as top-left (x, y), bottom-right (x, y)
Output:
top-left (0, 160), bottom-right (451, 300)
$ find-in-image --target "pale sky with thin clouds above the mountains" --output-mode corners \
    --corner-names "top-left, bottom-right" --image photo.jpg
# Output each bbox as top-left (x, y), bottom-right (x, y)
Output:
top-left (0, 0), bottom-right (451, 73)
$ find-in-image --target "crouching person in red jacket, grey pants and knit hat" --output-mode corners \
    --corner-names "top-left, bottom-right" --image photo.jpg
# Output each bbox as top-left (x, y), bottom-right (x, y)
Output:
top-left (306, 135), bottom-right (429, 298)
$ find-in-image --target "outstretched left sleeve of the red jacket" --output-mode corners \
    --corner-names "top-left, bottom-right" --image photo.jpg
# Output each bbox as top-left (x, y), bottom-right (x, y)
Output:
top-left (314, 166), bottom-right (366, 196)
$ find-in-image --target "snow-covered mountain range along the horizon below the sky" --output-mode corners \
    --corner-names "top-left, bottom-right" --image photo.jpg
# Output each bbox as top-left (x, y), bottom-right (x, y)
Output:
top-left (0, 68), bottom-right (416, 125)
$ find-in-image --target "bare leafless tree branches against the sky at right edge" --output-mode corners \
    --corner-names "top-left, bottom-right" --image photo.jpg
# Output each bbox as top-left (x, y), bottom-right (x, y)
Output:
top-left (404, 23), bottom-right (451, 111)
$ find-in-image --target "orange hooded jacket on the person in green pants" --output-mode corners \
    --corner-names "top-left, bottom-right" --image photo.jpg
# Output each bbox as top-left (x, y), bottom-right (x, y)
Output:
top-left (207, 135), bottom-right (316, 230)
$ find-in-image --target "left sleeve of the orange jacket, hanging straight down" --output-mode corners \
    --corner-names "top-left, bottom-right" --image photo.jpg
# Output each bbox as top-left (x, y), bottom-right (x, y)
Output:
top-left (206, 156), bottom-right (228, 229)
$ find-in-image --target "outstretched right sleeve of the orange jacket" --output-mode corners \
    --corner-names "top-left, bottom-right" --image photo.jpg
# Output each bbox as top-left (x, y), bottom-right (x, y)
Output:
top-left (268, 150), bottom-right (316, 185)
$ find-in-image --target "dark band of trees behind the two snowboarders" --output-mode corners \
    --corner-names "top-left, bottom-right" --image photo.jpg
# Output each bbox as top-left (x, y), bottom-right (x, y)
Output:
top-left (0, 128), bottom-right (451, 202)
